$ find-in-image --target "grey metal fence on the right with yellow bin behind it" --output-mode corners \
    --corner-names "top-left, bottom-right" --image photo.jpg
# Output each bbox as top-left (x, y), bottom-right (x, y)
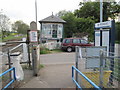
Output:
top-left (76, 46), bottom-right (120, 88)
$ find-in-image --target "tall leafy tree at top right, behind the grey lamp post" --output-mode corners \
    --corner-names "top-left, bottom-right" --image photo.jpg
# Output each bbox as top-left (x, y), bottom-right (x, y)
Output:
top-left (74, 2), bottom-right (120, 22)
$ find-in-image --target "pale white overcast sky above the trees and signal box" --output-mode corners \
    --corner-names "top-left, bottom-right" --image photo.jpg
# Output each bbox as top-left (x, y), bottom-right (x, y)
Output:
top-left (0, 0), bottom-right (119, 28)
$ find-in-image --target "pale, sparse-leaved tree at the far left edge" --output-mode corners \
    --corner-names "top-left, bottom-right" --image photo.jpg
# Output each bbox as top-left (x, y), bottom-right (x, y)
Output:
top-left (0, 12), bottom-right (11, 39)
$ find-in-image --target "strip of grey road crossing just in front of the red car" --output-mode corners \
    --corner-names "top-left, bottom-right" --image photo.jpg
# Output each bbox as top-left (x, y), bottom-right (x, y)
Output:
top-left (40, 52), bottom-right (75, 64)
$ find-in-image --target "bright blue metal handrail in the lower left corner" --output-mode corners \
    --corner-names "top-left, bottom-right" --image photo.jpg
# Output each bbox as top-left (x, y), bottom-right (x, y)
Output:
top-left (0, 67), bottom-right (16, 90)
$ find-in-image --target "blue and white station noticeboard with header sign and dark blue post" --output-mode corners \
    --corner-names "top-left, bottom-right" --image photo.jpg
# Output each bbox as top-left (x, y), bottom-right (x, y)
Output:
top-left (94, 20), bottom-right (115, 84)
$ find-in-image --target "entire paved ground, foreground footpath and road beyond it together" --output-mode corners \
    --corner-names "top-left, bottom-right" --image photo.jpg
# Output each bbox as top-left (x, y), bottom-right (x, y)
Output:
top-left (21, 53), bottom-right (75, 88)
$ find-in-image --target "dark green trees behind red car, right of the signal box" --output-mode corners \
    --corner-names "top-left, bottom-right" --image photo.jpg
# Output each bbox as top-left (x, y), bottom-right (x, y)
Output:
top-left (57, 10), bottom-right (95, 40)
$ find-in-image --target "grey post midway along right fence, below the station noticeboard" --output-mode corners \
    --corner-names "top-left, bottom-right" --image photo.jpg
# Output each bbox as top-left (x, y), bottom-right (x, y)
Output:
top-left (99, 50), bottom-right (104, 89)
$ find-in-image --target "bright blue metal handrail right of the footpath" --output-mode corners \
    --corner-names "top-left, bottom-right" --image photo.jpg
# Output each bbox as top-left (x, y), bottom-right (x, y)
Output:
top-left (72, 66), bottom-right (101, 90)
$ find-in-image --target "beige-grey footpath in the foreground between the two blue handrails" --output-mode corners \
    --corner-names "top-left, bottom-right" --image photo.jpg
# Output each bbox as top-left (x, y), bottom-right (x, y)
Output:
top-left (21, 64), bottom-right (75, 88)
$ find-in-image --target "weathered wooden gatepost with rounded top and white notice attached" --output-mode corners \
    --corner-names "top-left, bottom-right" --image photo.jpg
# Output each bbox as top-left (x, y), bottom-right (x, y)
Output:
top-left (28, 22), bottom-right (40, 76)
